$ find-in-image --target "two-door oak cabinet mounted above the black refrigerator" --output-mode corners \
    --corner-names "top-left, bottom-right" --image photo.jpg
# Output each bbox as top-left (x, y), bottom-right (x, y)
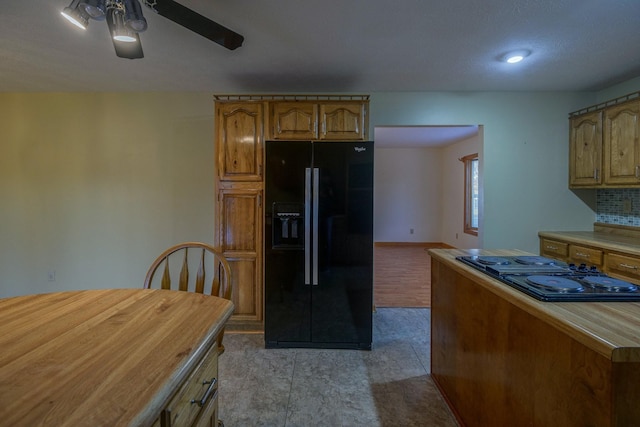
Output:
top-left (270, 101), bottom-right (368, 141)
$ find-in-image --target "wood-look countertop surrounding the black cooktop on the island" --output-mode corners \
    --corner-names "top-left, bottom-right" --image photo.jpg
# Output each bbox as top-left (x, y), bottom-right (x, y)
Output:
top-left (429, 249), bottom-right (640, 362)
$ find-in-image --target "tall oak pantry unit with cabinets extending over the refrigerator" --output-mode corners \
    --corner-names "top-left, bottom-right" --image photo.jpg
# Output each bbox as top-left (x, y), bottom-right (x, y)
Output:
top-left (214, 95), bottom-right (369, 330)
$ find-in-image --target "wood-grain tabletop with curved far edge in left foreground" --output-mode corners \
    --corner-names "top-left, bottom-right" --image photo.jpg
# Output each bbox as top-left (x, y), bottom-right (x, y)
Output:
top-left (0, 289), bottom-right (233, 426)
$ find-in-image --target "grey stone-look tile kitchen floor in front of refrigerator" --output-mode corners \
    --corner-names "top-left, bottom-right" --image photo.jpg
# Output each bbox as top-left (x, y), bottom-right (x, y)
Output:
top-left (219, 308), bottom-right (457, 427)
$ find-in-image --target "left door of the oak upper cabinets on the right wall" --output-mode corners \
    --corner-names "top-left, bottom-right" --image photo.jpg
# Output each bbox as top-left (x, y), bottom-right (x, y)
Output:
top-left (569, 111), bottom-right (602, 187)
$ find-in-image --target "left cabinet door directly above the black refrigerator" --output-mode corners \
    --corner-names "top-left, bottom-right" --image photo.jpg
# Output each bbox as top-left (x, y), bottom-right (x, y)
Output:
top-left (271, 102), bottom-right (318, 141)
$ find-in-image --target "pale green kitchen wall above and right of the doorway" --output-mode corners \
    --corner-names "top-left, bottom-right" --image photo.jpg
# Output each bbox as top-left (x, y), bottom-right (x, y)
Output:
top-left (370, 92), bottom-right (595, 253)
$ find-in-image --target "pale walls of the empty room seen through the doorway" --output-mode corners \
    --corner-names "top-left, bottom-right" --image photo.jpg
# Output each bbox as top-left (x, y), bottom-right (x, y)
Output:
top-left (374, 133), bottom-right (482, 248)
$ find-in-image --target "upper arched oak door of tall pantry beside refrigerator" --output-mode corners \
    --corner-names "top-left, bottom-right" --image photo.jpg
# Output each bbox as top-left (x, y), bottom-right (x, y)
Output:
top-left (216, 102), bottom-right (264, 181)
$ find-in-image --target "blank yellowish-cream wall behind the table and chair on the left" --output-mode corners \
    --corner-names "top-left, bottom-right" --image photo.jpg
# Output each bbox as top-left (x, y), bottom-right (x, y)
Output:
top-left (0, 93), bottom-right (214, 297)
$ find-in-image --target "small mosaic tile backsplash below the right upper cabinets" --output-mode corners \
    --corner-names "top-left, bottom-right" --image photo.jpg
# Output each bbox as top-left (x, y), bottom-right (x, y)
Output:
top-left (596, 188), bottom-right (640, 227)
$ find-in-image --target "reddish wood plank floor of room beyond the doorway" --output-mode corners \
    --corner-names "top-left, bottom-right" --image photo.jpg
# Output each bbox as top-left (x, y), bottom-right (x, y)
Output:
top-left (373, 243), bottom-right (448, 308)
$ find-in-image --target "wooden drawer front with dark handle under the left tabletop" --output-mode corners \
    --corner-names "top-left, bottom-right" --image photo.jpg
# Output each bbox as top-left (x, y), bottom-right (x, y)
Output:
top-left (163, 343), bottom-right (218, 427)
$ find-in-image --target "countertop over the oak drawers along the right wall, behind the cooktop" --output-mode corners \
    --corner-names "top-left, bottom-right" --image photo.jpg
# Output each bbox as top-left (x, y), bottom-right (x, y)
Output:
top-left (538, 231), bottom-right (640, 256)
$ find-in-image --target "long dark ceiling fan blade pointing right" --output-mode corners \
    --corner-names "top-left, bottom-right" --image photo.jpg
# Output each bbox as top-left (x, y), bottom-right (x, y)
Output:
top-left (144, 0), bottom-right (244, 50)
